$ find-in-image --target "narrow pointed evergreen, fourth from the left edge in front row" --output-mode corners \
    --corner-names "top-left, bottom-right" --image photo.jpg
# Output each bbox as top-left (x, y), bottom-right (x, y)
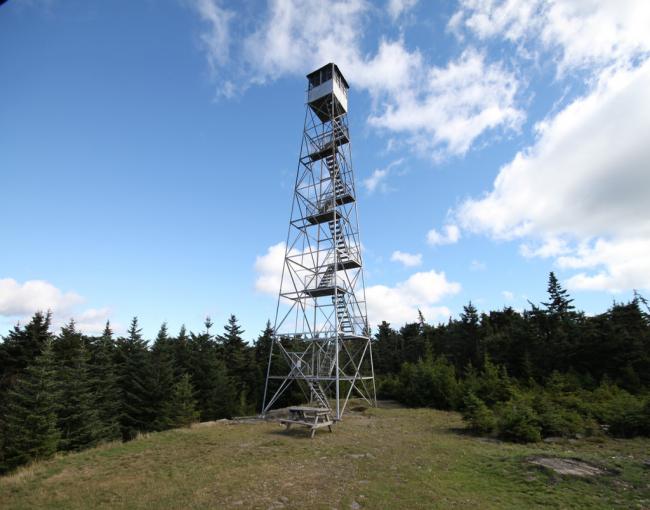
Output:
top-left (118, 317), bottom-right (156, 441)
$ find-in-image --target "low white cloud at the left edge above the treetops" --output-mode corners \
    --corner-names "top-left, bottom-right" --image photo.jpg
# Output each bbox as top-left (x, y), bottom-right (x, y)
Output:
top-left (0, 278), bottom-right (84, 317)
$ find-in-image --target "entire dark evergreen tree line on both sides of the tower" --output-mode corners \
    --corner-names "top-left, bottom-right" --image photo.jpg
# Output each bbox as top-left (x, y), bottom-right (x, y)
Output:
top-left (0, 273), bottom-right (650, 472)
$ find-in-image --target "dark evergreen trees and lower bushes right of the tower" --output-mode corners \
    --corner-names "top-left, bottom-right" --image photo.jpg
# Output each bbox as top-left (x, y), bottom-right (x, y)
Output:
top-left (373, 273), bottom-right (650, 442)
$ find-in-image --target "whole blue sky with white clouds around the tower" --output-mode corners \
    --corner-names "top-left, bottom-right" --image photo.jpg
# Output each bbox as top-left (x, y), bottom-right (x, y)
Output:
top-left (0, 0), bottom-right (650, 338)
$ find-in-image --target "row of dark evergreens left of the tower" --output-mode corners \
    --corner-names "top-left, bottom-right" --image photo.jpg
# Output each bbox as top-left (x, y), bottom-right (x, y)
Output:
top-left (0, 312), bottom-right (272, 472)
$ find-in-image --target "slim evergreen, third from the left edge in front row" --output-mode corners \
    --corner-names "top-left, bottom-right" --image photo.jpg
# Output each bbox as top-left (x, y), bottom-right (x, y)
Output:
top-left (89, 321), bottom-right (122, 441)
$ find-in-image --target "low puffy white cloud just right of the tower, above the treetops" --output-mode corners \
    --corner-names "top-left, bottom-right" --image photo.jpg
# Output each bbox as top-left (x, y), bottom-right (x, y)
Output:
top-left (366, 270), bottom-right (461, 326)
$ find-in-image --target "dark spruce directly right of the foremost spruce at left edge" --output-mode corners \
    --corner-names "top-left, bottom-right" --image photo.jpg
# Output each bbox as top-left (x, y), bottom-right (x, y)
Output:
top-left (54, 320), bottom-right (102, 451)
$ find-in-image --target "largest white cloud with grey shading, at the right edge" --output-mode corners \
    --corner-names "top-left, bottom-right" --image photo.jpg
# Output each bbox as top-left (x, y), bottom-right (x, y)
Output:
top-left (457, 59), bottom-right (650, 291)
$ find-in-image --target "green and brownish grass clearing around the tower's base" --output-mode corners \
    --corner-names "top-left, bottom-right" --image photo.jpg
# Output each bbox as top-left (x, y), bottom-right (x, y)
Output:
top-left (0, 409), bottom-right (650, 509)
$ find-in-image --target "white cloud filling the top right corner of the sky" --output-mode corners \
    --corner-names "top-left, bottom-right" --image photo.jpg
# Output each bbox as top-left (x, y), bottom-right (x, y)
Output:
top-left (449, 0), bottom-right (650, 72)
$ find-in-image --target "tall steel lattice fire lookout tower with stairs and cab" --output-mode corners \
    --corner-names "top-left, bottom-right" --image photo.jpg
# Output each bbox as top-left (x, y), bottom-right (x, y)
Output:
top-left (262, 63), bottom-right (376, 420)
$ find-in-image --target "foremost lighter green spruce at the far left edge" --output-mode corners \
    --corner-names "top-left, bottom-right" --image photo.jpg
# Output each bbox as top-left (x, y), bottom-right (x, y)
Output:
top-left (4, 339), bottom-right (60, 469)
